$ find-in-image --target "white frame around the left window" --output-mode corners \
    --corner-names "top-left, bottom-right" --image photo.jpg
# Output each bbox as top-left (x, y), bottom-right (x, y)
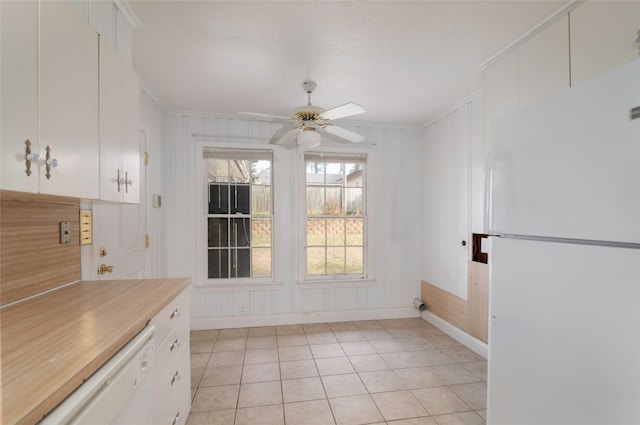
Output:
top-left (194, 142), bottom-right (282, 292)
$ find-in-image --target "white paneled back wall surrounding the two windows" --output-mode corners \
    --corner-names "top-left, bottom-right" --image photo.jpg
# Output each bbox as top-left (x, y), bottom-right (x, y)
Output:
top-left (163, 115), bottom-right (422, 329)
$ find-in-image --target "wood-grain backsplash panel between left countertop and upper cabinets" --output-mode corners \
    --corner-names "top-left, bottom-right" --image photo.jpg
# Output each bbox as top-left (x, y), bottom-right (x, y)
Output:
top-left (0, 193), bottom-right (81, 305)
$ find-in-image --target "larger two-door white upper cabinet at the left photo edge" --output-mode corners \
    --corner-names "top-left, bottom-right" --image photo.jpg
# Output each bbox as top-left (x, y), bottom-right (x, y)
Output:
top-left (0, 1), bottom-right (98, 199)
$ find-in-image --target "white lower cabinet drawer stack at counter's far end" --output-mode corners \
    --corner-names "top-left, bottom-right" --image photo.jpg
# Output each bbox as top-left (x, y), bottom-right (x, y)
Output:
top-left (151, 289), bottom-right (191, 425)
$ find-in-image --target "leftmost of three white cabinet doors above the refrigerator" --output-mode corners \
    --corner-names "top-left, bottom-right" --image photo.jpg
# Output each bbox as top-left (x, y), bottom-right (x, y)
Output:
top-left (482, 50), bottom-right (518, 159)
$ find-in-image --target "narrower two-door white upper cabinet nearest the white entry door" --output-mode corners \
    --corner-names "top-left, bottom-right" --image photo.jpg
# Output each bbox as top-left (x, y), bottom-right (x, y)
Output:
top-left (100, 37), bottom-right (140, 203)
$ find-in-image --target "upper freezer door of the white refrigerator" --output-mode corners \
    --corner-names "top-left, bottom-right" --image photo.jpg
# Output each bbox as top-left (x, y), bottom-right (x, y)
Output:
top-left (489, 60), bottom-right (640, 243)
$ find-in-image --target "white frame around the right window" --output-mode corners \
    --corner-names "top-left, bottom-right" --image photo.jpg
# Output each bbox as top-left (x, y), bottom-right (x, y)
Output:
top-left (296, 145), bottom-right (375, 288)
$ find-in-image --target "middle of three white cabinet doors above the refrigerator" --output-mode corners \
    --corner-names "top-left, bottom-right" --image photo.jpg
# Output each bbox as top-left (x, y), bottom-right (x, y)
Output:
top-left (518, 16), bottom-right (570, 107)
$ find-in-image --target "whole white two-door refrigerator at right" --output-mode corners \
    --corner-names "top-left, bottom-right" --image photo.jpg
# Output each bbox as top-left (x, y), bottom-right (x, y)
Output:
top-left (486, 60), bottom-right (640, 425)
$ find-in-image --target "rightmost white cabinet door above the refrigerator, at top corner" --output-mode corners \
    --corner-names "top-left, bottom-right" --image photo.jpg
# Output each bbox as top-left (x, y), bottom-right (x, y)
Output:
top-left (569, 1), bottom-right (640, 86)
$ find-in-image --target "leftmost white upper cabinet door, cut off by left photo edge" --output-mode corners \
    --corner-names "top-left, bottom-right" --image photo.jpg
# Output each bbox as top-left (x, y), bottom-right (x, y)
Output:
top-left (0, 1), bottom-right (38, 193)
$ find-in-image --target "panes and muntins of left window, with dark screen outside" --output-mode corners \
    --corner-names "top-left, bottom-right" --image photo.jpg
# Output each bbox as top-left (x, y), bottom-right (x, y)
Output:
top-left (203, 148), bottom-right (273, 279)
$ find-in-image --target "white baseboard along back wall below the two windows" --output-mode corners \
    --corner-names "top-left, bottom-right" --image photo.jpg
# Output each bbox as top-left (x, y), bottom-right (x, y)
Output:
top-left (191, 307), bottom-right (420, 331)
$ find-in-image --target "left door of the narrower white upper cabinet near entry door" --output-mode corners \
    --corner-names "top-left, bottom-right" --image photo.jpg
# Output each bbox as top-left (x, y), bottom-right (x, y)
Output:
top-left (100, 37), bottom-right (124, 202)
